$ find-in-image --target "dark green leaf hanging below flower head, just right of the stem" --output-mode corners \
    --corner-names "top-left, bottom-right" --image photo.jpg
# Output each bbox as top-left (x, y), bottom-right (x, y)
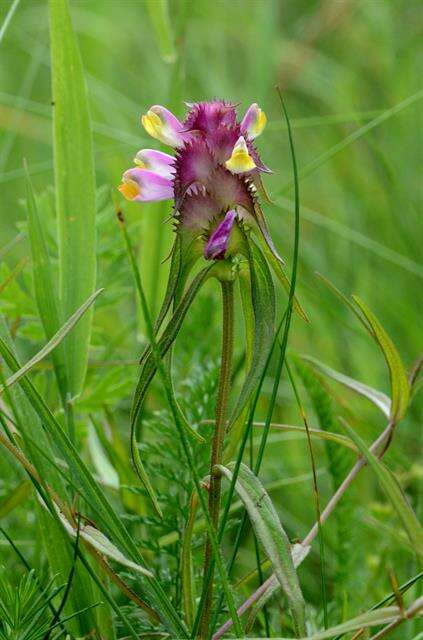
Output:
top-left (228, 234), bottom-right (275, 429)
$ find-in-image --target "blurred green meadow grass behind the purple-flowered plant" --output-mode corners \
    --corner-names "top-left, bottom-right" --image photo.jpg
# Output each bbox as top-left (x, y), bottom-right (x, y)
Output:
top-left (0, 0), bottom-right (423, 637)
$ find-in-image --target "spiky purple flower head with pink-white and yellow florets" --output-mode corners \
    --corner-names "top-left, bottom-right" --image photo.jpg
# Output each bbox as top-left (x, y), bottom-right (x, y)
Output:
top-left (119, 100), bottom-right (273, 260)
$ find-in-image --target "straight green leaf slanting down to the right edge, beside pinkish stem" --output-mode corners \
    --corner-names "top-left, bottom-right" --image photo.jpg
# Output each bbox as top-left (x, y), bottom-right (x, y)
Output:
top-left (342, 420), bottom-right (423, 562)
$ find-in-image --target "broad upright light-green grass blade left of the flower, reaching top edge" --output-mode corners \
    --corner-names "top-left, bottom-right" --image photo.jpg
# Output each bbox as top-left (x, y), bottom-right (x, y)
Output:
top-left (49, 0), bottom-right (96, 396)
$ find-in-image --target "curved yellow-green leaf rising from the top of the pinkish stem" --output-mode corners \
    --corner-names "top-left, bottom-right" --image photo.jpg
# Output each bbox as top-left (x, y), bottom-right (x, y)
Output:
top-left (352, 296), bottom-right (410, 422)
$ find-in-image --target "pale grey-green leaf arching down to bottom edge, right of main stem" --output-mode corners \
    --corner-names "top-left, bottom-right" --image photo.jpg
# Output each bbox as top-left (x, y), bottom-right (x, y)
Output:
top-left (218, 463), bottom-right (305, 637)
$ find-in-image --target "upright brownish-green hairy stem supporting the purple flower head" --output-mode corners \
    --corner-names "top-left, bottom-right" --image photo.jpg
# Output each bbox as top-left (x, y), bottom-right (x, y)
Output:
top-left (199, 282), bottom-right (234, 639)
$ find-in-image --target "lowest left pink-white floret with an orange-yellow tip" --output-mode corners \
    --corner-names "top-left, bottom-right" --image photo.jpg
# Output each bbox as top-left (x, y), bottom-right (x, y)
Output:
top-left (118, 168), bottom-right (173, 202)
